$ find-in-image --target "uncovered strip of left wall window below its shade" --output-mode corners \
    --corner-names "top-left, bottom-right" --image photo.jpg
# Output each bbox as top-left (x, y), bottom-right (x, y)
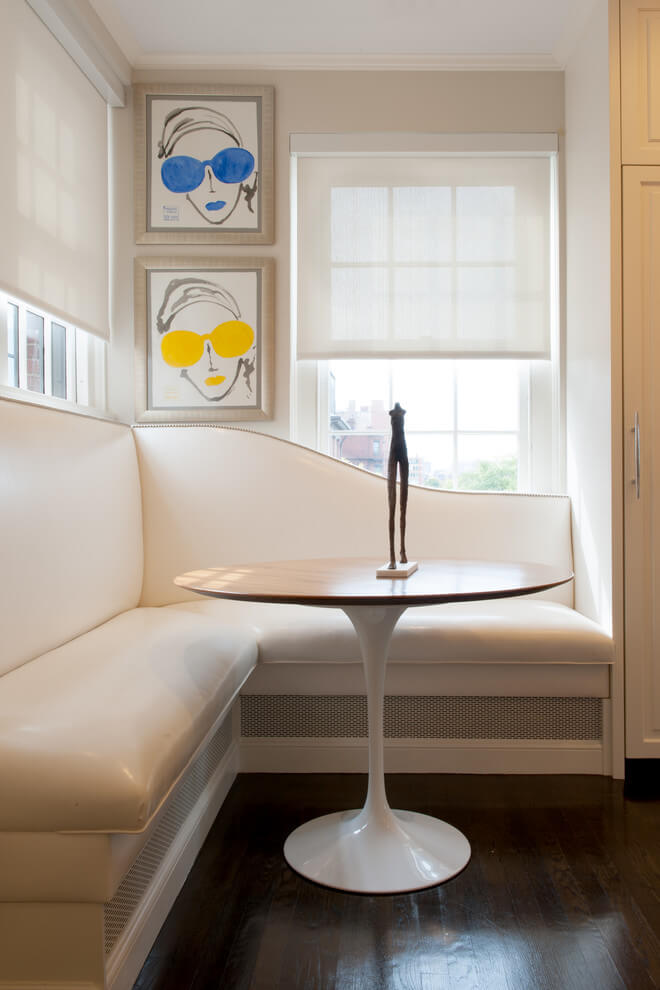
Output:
top-left (0, 294), bottom-right (106, 411)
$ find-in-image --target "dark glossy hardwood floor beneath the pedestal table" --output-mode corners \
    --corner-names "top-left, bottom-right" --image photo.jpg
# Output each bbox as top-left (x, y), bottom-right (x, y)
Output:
top-left (135, 774), bottom-right (660, 990)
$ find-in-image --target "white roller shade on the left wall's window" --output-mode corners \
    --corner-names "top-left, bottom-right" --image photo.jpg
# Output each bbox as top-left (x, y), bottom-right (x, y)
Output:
top-left (0, 0), bottom-right (109, 338)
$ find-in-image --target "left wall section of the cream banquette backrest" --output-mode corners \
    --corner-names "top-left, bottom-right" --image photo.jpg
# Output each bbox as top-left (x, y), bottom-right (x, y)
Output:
top-left (0, 399), bottom-right (143, 674)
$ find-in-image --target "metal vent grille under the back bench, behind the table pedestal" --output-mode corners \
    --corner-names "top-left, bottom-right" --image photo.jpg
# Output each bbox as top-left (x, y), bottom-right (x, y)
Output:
top-left (241, 694), bottom-right (603, 740)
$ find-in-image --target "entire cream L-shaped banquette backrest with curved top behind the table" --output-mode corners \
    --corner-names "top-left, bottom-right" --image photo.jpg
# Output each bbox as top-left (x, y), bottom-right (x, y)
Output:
top-left (0, 399), bottom-right (572, 674)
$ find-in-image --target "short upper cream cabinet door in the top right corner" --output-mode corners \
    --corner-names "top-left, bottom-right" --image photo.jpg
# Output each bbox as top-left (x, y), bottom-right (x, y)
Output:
top-left (621, 0), bottom-right (660, 165)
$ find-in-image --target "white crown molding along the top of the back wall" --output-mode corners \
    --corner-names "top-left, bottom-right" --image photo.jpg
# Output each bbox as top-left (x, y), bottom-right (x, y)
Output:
top-left (133, 52), bottom-right (563, 72)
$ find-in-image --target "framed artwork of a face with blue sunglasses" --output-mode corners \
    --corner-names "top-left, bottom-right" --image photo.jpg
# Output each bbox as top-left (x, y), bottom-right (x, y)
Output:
top-left (134, 85), bottom-right (273, 244)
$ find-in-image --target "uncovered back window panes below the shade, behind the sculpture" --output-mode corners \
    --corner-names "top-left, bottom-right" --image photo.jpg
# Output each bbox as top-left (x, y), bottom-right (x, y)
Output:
top-left (323, 360), bottom-right (529, 490)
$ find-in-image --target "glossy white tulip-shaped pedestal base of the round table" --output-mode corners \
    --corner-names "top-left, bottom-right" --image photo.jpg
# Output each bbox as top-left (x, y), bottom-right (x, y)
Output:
top-left (284, 605), bottom-right (470, 894)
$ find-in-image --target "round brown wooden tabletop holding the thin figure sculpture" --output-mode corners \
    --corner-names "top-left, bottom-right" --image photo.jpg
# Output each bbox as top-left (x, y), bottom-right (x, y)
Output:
top-left (174, 557), bottom-right (573, 606)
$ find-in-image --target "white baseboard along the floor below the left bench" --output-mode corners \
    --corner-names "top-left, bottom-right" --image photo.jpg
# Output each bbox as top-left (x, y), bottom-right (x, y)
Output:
top-left (107, 742), bottom-right (239, 990)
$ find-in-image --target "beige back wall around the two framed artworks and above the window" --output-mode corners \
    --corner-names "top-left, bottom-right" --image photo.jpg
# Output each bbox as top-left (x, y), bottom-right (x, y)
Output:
top-left (109, 70), bottom-right (564, 437)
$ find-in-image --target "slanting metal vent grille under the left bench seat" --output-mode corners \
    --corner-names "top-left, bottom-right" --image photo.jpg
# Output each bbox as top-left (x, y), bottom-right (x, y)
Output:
top-left (103, 717), bottom-right (232, 955)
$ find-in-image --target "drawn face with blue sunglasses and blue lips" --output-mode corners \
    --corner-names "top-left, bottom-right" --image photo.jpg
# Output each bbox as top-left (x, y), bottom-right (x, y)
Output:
top-left (158, 107), bottom-right (257, 226)
